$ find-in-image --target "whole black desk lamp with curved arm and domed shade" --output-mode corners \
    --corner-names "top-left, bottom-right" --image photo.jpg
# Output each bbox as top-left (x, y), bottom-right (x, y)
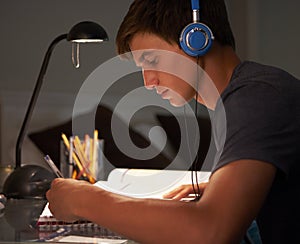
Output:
top-left (3, 21), bottom-right (108, 198)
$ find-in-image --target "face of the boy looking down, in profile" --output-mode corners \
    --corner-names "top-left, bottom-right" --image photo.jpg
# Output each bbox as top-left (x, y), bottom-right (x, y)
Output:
top-left (130, 33), bottom-right (197, 107)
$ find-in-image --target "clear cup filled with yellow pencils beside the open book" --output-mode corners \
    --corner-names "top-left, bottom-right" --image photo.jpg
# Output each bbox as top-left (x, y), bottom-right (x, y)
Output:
top-left (60, 130), bottom-right (104, 184)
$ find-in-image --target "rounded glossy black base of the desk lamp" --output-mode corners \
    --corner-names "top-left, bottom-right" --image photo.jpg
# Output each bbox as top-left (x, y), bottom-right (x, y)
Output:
top-left (3, 165), bottom-right (55, 199)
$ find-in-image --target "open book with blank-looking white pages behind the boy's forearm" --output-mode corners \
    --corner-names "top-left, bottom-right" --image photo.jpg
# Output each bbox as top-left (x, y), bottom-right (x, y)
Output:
top-left (95, 168), bottom-right (210, 199)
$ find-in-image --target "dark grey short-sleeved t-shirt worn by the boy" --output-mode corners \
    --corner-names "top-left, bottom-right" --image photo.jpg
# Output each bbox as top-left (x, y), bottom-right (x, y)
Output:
top-left (213, 61), bottom-right (300, 244)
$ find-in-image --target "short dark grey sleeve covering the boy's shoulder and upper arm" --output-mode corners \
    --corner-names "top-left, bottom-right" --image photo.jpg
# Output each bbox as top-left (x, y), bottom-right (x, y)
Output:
top-left (214, 83), bottom-right (293, 174)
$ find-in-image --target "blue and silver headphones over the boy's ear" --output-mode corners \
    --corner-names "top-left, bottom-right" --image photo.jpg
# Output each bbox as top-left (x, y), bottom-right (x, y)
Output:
top-left (179, 0), bottom-right (214, 57)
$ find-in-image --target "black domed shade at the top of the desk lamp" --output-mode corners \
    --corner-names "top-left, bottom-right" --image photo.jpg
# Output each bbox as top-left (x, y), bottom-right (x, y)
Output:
top-left (67, 21), bottom-right (108, 43)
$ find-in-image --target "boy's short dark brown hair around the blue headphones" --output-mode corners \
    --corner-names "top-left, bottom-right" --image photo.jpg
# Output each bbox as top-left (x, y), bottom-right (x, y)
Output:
top-left (116, 0), bottom-right (235, 54)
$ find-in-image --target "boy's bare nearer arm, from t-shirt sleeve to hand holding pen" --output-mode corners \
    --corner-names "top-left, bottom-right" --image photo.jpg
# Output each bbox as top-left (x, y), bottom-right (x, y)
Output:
top-left (47, 160), bottom-right (276, 243)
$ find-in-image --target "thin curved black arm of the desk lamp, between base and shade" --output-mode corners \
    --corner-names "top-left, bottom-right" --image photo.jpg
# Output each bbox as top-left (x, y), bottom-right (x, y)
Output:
top-left (15, 34), bottom-right (67, 168)
